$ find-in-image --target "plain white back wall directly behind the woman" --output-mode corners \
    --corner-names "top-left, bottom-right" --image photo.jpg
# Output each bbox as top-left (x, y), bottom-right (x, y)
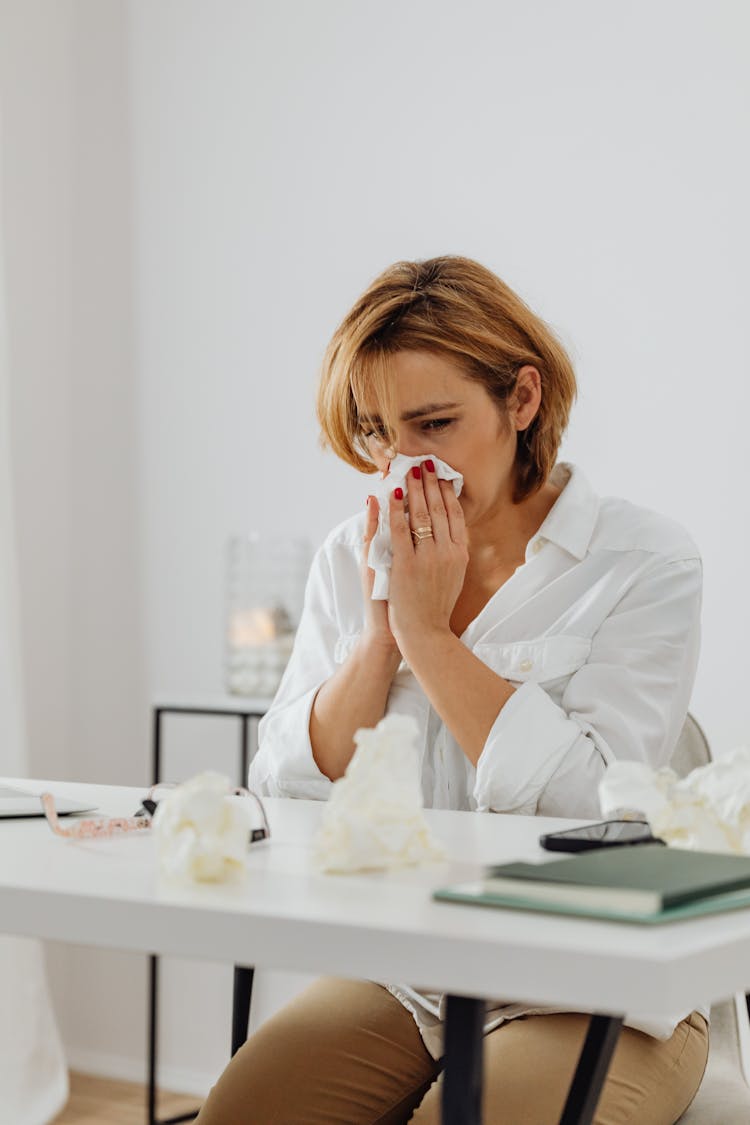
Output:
top-left (132, 0), bottom-right (750, 748)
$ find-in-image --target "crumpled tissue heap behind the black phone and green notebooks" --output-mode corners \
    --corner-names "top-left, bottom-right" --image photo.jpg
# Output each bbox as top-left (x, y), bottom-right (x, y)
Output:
top-left (599, 746), bottom-right (750, 855)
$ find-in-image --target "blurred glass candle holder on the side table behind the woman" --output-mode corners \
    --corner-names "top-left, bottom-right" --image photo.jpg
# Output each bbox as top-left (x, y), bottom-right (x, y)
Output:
top-left (226, 534), bottom-right (311, 699)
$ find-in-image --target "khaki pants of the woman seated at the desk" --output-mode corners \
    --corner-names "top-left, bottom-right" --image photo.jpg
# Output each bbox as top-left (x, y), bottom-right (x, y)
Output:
top-left (198, 978), bottom-right (708, 1125)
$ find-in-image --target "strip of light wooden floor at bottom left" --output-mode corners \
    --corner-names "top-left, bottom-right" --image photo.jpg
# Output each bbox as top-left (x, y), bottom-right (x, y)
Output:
top-left (54, 1073), bottom-right (200, 1125)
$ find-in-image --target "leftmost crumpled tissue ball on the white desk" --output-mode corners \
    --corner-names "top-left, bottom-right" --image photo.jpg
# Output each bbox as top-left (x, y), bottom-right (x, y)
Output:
top-left (153, 771), bottom-right (252, 883)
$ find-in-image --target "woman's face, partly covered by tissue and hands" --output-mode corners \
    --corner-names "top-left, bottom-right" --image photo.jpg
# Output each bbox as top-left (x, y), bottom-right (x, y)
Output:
top-left (367, 351), bottom-right (541, 527)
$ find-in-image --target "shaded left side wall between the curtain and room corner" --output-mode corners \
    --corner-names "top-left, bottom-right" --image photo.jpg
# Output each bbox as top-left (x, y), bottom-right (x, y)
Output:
top-left (0, 0), bottom-right (157, 1093)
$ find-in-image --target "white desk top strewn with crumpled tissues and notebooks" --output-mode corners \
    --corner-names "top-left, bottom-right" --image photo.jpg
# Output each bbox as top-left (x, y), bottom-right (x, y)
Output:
top-left (0, 779), bottom-right (750, 1125)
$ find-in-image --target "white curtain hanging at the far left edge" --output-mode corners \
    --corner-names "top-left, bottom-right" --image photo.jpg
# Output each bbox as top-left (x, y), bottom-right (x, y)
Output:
top-left (0, 116), bottom-right (67, 1125)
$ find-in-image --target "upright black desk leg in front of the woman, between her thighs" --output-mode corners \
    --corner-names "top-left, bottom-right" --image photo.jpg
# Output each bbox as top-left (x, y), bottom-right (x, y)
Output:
top-left (442, 996), bottom-right (486, 1125)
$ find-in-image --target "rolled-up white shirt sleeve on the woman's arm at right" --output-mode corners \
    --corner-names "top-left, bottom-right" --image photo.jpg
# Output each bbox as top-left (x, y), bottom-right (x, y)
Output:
top-left (473, 558), bottom-right (702, 817)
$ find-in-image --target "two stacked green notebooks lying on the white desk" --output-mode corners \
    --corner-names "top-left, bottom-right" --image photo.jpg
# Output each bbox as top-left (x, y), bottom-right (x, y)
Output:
top-left (434, 844), bottom-right (750, 923)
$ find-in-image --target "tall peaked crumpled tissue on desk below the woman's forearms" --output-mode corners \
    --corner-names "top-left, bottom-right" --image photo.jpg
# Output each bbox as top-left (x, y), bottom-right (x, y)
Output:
top-left (313, 714), bottom-right (444, 873)
